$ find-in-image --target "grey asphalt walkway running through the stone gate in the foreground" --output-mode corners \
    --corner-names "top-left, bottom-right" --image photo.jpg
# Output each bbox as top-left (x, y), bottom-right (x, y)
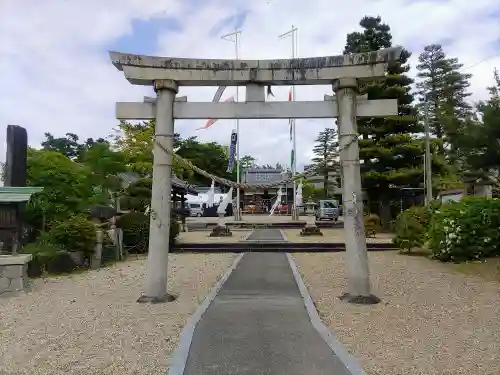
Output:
top-left (184, 253), bottom-right (350, 375)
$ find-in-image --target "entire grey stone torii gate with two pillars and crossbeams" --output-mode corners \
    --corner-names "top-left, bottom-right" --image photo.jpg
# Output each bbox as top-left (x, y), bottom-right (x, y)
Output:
top-left (110, 47), bottom-right (401, 303)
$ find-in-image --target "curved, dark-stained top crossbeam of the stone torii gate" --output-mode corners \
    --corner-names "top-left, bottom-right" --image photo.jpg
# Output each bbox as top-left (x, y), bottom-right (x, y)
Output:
top-left (109, 47), bottom-right (402, 86)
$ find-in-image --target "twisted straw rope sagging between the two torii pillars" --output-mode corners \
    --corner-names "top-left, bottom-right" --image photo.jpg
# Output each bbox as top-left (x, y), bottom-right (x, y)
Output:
top-left (154, 135), bottom-right (358, 190)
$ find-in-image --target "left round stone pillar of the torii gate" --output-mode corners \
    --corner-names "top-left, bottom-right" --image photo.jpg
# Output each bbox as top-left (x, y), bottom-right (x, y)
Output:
top-left (137, 79), bottom-right (178, 303)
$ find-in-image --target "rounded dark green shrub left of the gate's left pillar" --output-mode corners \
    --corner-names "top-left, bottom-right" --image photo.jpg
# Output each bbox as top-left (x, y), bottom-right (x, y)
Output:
top-left (49, 215), bottom-right (96, 255)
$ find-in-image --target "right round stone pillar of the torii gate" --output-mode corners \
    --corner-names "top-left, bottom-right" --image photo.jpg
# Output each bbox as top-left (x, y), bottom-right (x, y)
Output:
top-left (333, 78), bottom-right (380, 304)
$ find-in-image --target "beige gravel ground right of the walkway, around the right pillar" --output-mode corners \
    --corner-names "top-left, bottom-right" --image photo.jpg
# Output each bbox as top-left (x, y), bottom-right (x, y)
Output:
top-left (294, 252), bottom-right (500, 375)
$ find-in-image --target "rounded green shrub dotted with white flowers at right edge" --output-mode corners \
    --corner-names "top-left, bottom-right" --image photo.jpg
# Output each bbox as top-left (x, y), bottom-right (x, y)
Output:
top-left (428, 197), bottom-right (500, 262)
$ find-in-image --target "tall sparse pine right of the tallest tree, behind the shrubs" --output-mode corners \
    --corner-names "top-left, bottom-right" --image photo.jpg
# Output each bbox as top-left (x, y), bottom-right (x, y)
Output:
top-left (417, 44), bottom-right (472, 157)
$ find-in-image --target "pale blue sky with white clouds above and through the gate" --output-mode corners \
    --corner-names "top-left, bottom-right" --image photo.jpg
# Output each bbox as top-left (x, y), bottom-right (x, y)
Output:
top-left (0, 0), bottom-right (500, 170)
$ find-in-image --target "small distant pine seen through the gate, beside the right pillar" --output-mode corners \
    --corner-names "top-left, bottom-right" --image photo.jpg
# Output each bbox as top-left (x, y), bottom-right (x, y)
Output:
top-left (312, 128), bottom-right (339, 197)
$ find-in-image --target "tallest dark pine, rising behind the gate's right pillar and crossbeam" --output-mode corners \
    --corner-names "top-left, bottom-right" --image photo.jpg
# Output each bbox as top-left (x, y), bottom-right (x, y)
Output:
top-left (344, 17), bottom-right (423, 226)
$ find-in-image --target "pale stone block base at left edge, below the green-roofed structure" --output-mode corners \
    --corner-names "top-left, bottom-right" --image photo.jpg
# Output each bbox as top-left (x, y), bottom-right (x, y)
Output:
top-left (0, 254), bottom-right (31, 296)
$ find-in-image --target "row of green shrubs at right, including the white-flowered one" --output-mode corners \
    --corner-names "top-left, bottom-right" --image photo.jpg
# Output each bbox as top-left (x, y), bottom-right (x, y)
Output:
top-left (394, 197), bottom-right (500, 262)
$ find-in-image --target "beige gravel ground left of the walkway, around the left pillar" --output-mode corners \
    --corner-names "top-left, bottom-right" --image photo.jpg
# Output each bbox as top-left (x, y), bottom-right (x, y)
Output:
top-left (0, 254), bottom-right (236, 375)
